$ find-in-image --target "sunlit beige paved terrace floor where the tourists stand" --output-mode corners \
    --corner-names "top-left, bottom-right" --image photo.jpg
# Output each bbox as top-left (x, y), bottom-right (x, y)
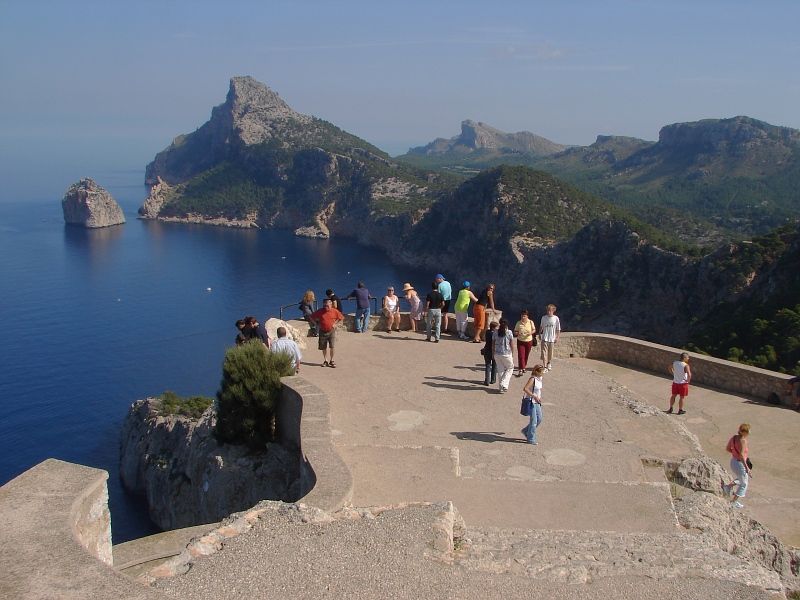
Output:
top-left (0, 322), bottom-right (800, 598)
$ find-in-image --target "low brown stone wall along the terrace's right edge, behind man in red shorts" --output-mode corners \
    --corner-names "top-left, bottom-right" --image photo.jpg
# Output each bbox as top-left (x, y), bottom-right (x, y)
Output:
top-left (554, 332), bottom-right (794, 406)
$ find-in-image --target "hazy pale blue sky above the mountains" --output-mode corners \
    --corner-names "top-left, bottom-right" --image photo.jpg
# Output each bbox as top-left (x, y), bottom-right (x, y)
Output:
top-left (0, 0), bottom-right (800, 197)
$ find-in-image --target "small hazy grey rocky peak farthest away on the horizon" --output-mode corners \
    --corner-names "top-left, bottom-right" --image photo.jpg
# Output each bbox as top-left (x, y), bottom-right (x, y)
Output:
top-left (408, 119), bottom-right (569, 156)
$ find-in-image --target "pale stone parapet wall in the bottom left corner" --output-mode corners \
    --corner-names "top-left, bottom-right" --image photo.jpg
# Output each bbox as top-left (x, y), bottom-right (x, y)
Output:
top-left (0, 459), bottom-right (164, 600)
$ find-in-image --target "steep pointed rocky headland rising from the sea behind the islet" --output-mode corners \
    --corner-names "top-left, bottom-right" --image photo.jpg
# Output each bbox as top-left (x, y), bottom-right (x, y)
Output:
top-left (139, 77), bottom-right (454, 237)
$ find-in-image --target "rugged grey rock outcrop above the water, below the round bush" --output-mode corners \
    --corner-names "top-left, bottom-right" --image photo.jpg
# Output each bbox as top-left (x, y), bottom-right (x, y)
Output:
top-left (120, 398), bottom-right (301, 529)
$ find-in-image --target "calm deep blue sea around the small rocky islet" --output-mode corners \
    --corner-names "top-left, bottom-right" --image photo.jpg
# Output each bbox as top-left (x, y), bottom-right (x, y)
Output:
top-left (0, 171), bottom-right (435, 543)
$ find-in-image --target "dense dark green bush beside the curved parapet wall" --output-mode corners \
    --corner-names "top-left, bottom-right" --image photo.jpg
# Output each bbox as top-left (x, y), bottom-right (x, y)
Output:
top-left (214, 341), bottom-right (292, 450)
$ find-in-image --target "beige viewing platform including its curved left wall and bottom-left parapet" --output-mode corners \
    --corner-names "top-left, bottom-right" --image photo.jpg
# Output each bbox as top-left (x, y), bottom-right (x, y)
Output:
top-left (0, 319), bottom-right (800, 599)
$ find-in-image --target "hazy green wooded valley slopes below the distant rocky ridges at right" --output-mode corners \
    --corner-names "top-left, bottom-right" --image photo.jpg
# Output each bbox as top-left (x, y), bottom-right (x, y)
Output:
top-left (398, 138), bottom-right (800, 245)
